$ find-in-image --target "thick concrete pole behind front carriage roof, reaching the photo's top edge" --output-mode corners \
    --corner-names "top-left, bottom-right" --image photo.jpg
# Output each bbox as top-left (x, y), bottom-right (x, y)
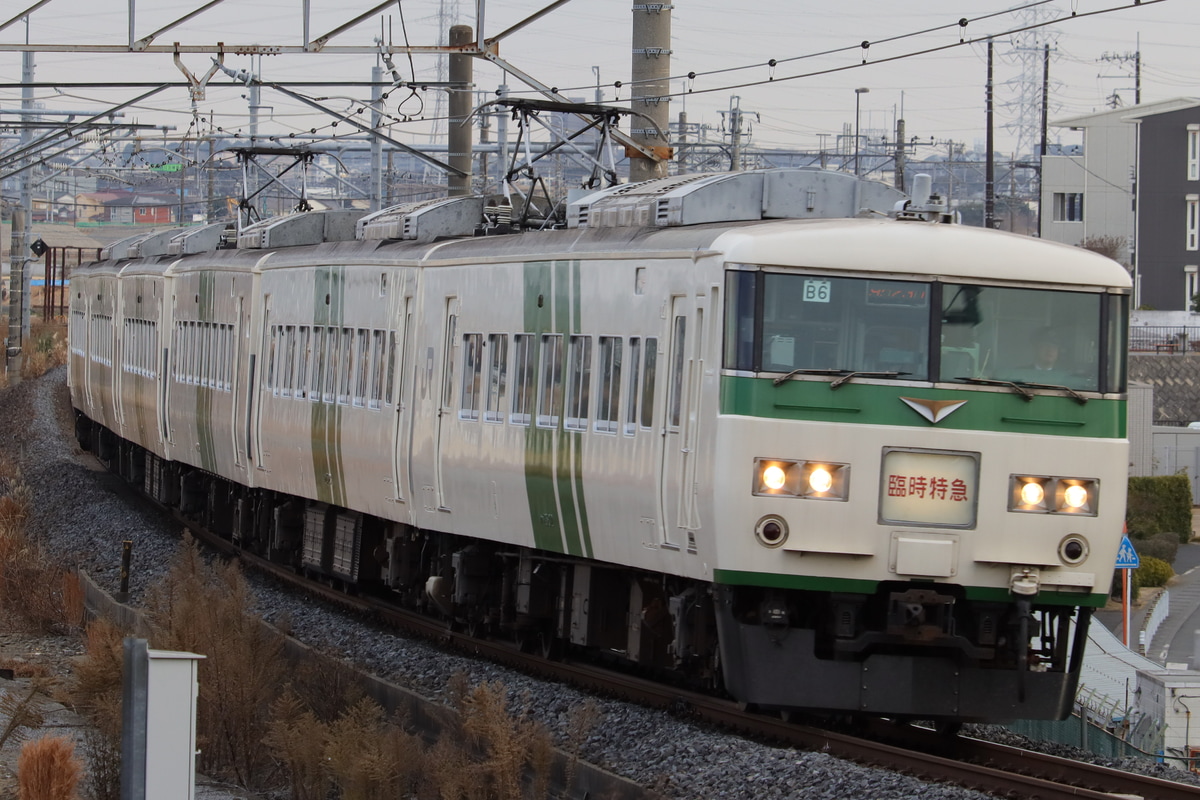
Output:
top-left (629, 0), bottom-right (672, 182)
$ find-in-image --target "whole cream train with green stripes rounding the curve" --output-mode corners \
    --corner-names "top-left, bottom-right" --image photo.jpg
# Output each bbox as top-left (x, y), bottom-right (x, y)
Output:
top-left (67, 169), bottom-right (1130, 726)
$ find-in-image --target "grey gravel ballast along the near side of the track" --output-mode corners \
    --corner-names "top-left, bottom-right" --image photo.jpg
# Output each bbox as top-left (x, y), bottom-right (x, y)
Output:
top-left (0, 368), bottom-right (1183, 800)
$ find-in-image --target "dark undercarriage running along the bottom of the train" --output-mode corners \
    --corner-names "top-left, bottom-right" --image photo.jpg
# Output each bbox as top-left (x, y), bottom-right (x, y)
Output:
top-left (77, 415), bottom-right (1090, 721)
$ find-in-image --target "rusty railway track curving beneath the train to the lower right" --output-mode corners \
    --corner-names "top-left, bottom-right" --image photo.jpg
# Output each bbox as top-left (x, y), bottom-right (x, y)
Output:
top-left (164, 509), bottom-right (1200, 800)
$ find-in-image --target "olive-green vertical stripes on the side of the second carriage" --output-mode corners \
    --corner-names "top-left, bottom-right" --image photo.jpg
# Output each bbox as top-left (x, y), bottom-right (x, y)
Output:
top-left (310, 266), bottom-right (345, 506)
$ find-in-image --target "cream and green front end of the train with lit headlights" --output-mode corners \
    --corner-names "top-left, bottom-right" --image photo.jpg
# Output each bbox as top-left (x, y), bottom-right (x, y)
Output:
top-left (713, 219), bottom-right (1129, 721)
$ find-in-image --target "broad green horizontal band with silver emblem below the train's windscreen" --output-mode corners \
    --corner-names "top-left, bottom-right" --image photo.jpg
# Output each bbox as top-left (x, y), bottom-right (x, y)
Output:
top-left (721, 375), bottom-right (1126, 439)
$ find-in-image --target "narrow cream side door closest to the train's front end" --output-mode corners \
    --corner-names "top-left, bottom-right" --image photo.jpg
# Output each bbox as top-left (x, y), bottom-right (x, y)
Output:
top-left (659, 296), bottom-right (702, 548)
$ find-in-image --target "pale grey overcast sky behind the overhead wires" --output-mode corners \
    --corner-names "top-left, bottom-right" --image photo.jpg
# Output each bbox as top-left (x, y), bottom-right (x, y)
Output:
top-left (0, 0), bottom-right (1200, 163)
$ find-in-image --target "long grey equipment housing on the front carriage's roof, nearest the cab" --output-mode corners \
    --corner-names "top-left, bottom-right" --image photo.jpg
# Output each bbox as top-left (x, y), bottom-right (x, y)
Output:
top-left (566, 169), bottom-right (905, 228)
